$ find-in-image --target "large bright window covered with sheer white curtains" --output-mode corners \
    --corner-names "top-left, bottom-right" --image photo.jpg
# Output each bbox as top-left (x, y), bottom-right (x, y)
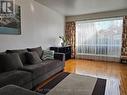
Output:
top-left (76, 17), bottom-right (123, 57)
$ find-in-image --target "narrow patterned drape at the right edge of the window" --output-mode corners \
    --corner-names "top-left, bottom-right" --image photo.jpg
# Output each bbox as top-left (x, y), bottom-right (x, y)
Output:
top-left (121, 16), bottom-right (127, 56)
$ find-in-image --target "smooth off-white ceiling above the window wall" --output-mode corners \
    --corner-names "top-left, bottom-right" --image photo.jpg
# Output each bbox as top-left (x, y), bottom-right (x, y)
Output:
top-left (35, 0), bottom-right (127, 16)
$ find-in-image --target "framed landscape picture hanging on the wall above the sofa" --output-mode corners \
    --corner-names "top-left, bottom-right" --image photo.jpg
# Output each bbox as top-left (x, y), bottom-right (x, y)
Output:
top-left (0, 5), bottom-right (21, 35)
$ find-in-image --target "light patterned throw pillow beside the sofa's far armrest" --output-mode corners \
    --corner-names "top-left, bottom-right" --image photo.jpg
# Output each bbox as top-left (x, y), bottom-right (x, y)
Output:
top-left (41, 50), bottom-right (54, 60)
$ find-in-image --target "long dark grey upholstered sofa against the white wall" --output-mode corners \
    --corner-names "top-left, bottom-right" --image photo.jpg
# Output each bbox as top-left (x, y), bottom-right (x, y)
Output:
top-left (0, 47), bottom-right (65, 89)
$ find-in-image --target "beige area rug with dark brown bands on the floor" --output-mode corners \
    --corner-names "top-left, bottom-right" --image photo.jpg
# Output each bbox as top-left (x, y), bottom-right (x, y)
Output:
top-left (39, 72), bottom-right (106, 95)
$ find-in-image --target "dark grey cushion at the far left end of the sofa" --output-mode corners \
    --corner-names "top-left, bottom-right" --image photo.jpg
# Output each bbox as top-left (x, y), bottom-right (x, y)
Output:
top-left (0, 53), bottom-right (23, 73)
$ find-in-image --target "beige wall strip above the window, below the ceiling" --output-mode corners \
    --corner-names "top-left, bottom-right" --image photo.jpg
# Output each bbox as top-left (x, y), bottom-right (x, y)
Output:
top-left (66, 9), bottom-right (127, 22)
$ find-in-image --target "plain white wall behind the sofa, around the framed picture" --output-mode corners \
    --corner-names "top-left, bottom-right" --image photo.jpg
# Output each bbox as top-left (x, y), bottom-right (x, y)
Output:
top-left (0, 0), bottom-right (64, 51)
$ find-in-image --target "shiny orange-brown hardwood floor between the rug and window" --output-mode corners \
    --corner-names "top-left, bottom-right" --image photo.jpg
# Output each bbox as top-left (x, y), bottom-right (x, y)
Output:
top-left (65, 59), bottom-right (127, 95)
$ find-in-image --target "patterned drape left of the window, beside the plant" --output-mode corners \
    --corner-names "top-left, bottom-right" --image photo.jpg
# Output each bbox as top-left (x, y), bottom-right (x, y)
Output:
top-left (65, 21), bottom-right (76, 58)
